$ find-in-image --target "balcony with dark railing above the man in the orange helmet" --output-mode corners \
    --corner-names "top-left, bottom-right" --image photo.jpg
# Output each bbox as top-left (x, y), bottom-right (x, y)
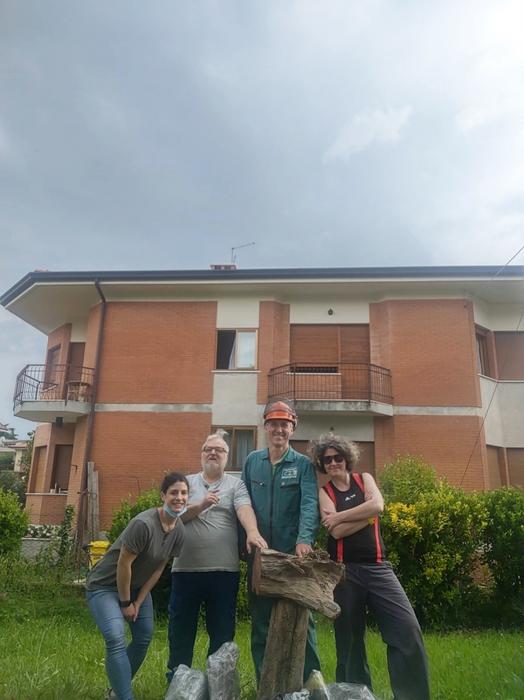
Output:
top-left (268, 362), bottom-right (393, 416)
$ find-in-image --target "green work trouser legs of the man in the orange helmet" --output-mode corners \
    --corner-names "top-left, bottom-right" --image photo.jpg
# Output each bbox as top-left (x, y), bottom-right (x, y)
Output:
top-left (248, 590), bottom-right (320, 683)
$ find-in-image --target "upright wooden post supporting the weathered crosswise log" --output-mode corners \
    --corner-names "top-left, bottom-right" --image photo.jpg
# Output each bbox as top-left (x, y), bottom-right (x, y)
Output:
top-left (257, 599), bottom-right (309, 700)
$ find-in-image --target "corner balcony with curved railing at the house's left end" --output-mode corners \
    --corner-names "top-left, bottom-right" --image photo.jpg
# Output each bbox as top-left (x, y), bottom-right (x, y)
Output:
top-left (13, 364), bottom-right (94, 423)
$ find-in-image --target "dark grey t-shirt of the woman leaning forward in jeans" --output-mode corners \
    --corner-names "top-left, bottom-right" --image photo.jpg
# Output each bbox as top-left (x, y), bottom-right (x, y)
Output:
top-left (86, 508), bottom-right (185, 591)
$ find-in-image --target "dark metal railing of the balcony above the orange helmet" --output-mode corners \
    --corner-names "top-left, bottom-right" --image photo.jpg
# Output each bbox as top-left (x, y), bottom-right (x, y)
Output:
top-left (268, 362), bottom-right (393, 404)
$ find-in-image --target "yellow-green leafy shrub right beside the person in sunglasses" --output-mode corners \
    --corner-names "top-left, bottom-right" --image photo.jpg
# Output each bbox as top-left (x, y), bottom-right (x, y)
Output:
top-left (382, 484), bottom-right (487, 628)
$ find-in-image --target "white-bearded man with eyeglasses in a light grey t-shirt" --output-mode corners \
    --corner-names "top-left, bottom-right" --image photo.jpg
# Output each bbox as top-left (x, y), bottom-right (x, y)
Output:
top-left (167, 431), bottom-right (267, 680)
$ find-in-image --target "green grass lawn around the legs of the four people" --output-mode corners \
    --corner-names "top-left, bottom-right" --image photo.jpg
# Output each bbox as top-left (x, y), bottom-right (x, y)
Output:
top-left (0, 587), bottom-right (524, 700)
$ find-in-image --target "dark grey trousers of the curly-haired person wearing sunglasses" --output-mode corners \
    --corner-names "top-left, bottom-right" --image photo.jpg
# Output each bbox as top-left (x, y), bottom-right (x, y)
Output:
top-left (334, 562), bottom-right (429, 700)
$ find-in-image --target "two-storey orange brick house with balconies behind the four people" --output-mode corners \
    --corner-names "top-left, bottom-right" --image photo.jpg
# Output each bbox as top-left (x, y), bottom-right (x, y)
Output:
top-left (0, 266), bottom-right (524, 526)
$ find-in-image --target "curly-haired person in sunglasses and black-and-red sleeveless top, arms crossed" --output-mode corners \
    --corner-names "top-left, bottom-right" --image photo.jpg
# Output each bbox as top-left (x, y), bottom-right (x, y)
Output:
top-left (310, 433), bottom-right (429, 700)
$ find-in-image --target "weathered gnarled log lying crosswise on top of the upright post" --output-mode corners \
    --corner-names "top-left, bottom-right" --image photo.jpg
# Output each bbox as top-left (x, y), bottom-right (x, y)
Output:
top-left (252, 549), bottom-right (344, 620)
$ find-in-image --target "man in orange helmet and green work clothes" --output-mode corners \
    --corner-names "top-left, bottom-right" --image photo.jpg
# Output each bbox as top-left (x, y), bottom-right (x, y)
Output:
top-left (242, 401), bottom-right (320, 681)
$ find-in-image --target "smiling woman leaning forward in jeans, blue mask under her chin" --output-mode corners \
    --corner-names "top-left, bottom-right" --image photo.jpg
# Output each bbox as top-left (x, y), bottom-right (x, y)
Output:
top-left (86, 473), bottom-right (188, 700)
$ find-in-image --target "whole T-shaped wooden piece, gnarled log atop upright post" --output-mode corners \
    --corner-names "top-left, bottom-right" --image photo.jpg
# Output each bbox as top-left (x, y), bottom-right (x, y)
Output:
top-left (252, 549), bottom-right (344, 700)
